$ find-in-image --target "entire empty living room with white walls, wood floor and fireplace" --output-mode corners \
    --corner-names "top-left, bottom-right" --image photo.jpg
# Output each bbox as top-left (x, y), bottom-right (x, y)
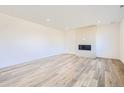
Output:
top-left (0, 5), bottom-right (124, 87)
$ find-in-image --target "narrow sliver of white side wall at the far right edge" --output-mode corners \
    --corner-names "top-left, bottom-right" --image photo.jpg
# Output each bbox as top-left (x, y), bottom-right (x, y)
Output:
top-left (120, 19), bottom-right (124, 63)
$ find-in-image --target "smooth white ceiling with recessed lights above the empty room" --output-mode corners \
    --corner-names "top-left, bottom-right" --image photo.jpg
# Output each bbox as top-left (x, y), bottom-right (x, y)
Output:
top-left (0, 5), bottom-right (120, 29)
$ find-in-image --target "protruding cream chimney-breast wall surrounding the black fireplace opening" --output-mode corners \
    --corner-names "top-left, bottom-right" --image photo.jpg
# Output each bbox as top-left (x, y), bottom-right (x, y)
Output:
top-left (76, 26), bottom-right (96, 58)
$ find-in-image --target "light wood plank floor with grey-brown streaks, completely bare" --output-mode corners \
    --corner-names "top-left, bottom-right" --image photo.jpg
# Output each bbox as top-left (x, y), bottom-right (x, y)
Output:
top-left (0, 54), bottom-right (124, 87)
